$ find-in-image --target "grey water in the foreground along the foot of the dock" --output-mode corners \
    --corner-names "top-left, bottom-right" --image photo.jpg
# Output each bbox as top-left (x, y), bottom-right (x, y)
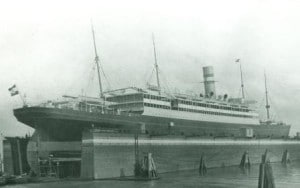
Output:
top-left (4, 161), bottom-right (300, 188)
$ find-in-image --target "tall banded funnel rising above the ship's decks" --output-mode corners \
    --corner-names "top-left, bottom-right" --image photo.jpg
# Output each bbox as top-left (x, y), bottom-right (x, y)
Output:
top-left (203, 66), bottom-right (216, 98)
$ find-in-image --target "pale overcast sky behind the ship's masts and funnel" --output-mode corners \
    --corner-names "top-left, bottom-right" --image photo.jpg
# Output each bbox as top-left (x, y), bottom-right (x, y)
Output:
top-left (0, 0), bottom-right (300, 136)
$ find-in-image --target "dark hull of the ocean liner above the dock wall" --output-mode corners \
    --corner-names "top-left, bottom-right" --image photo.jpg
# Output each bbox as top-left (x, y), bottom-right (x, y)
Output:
top-left (14, 107), bottom-right (290, 141)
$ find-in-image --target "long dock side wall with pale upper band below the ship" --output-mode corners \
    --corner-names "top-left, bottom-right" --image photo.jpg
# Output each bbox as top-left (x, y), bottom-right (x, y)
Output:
top-left (81, 131), bottom-right (300, 179)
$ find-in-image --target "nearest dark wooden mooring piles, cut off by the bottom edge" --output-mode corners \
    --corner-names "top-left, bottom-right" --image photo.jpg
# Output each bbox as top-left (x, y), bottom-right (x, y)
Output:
top-left (258, 150), bottom-right (275, 188)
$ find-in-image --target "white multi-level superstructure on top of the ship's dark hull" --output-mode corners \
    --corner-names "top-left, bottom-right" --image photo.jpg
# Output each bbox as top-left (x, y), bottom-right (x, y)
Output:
top-left (106, 87), bottom-right (259, 125)
